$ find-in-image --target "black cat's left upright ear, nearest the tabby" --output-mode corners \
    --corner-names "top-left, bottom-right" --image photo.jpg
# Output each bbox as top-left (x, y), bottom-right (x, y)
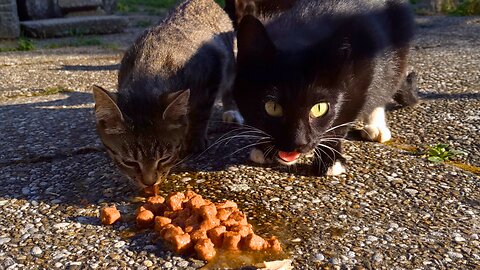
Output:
top-left (237, 15), bottom-right (276, 67)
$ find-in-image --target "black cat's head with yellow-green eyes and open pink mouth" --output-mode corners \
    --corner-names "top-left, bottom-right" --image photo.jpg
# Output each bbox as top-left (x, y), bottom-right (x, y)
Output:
top-left (234, 17), bottom-right (362, 165)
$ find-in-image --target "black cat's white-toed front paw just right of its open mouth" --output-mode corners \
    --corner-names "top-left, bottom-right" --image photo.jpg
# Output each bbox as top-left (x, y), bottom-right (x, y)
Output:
top-left (312, 142), bottom-right (346, 175)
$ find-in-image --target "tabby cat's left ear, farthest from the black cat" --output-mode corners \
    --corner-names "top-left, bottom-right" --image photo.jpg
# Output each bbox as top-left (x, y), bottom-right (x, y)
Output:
top-left (93, 85), bottom-right (125, 135)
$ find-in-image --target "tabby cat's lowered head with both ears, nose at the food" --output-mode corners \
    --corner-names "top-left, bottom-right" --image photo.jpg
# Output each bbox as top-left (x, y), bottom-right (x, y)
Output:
top-left (94, 87), bottom-right (189, 187)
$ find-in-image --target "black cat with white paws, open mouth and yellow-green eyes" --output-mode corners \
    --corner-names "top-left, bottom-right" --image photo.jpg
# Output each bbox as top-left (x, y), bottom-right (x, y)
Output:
top-left (234, 0), bottom-right (417, 175)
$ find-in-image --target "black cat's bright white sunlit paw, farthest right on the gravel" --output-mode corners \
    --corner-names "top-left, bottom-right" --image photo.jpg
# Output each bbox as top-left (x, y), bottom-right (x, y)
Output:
top-left (361, 107), bottom-right (392, 143)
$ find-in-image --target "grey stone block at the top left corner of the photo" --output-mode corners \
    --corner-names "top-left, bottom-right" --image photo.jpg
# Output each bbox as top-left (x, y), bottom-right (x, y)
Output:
top-left (0, 0), bottom-right (20, 38)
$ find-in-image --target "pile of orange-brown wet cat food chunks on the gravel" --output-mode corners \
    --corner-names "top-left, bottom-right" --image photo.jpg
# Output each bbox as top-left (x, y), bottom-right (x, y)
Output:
top-left (101, 191), bottom-right (282, 261)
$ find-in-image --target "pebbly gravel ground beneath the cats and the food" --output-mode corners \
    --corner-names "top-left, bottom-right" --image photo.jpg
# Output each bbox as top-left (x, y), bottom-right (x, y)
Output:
top-left (0, 17), bottom-right (480, 269)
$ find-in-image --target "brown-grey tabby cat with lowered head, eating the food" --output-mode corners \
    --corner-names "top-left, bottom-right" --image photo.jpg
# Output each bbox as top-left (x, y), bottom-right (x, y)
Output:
top-left (93, 0), bottom-right (243, 186)
